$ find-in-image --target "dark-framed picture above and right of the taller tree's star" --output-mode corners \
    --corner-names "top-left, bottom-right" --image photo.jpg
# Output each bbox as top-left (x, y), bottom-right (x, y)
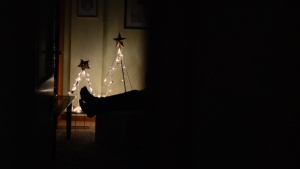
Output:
top-left (124, 0), bottom-right (147, 29)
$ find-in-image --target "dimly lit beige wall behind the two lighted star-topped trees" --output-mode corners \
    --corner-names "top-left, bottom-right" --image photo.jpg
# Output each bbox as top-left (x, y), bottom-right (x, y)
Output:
top-left (63, 0), bottom-right (147, 105)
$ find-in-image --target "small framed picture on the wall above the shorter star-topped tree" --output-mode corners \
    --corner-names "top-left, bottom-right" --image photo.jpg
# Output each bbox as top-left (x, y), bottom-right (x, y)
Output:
top-left (77, 0), bottom-right (98, 17)
